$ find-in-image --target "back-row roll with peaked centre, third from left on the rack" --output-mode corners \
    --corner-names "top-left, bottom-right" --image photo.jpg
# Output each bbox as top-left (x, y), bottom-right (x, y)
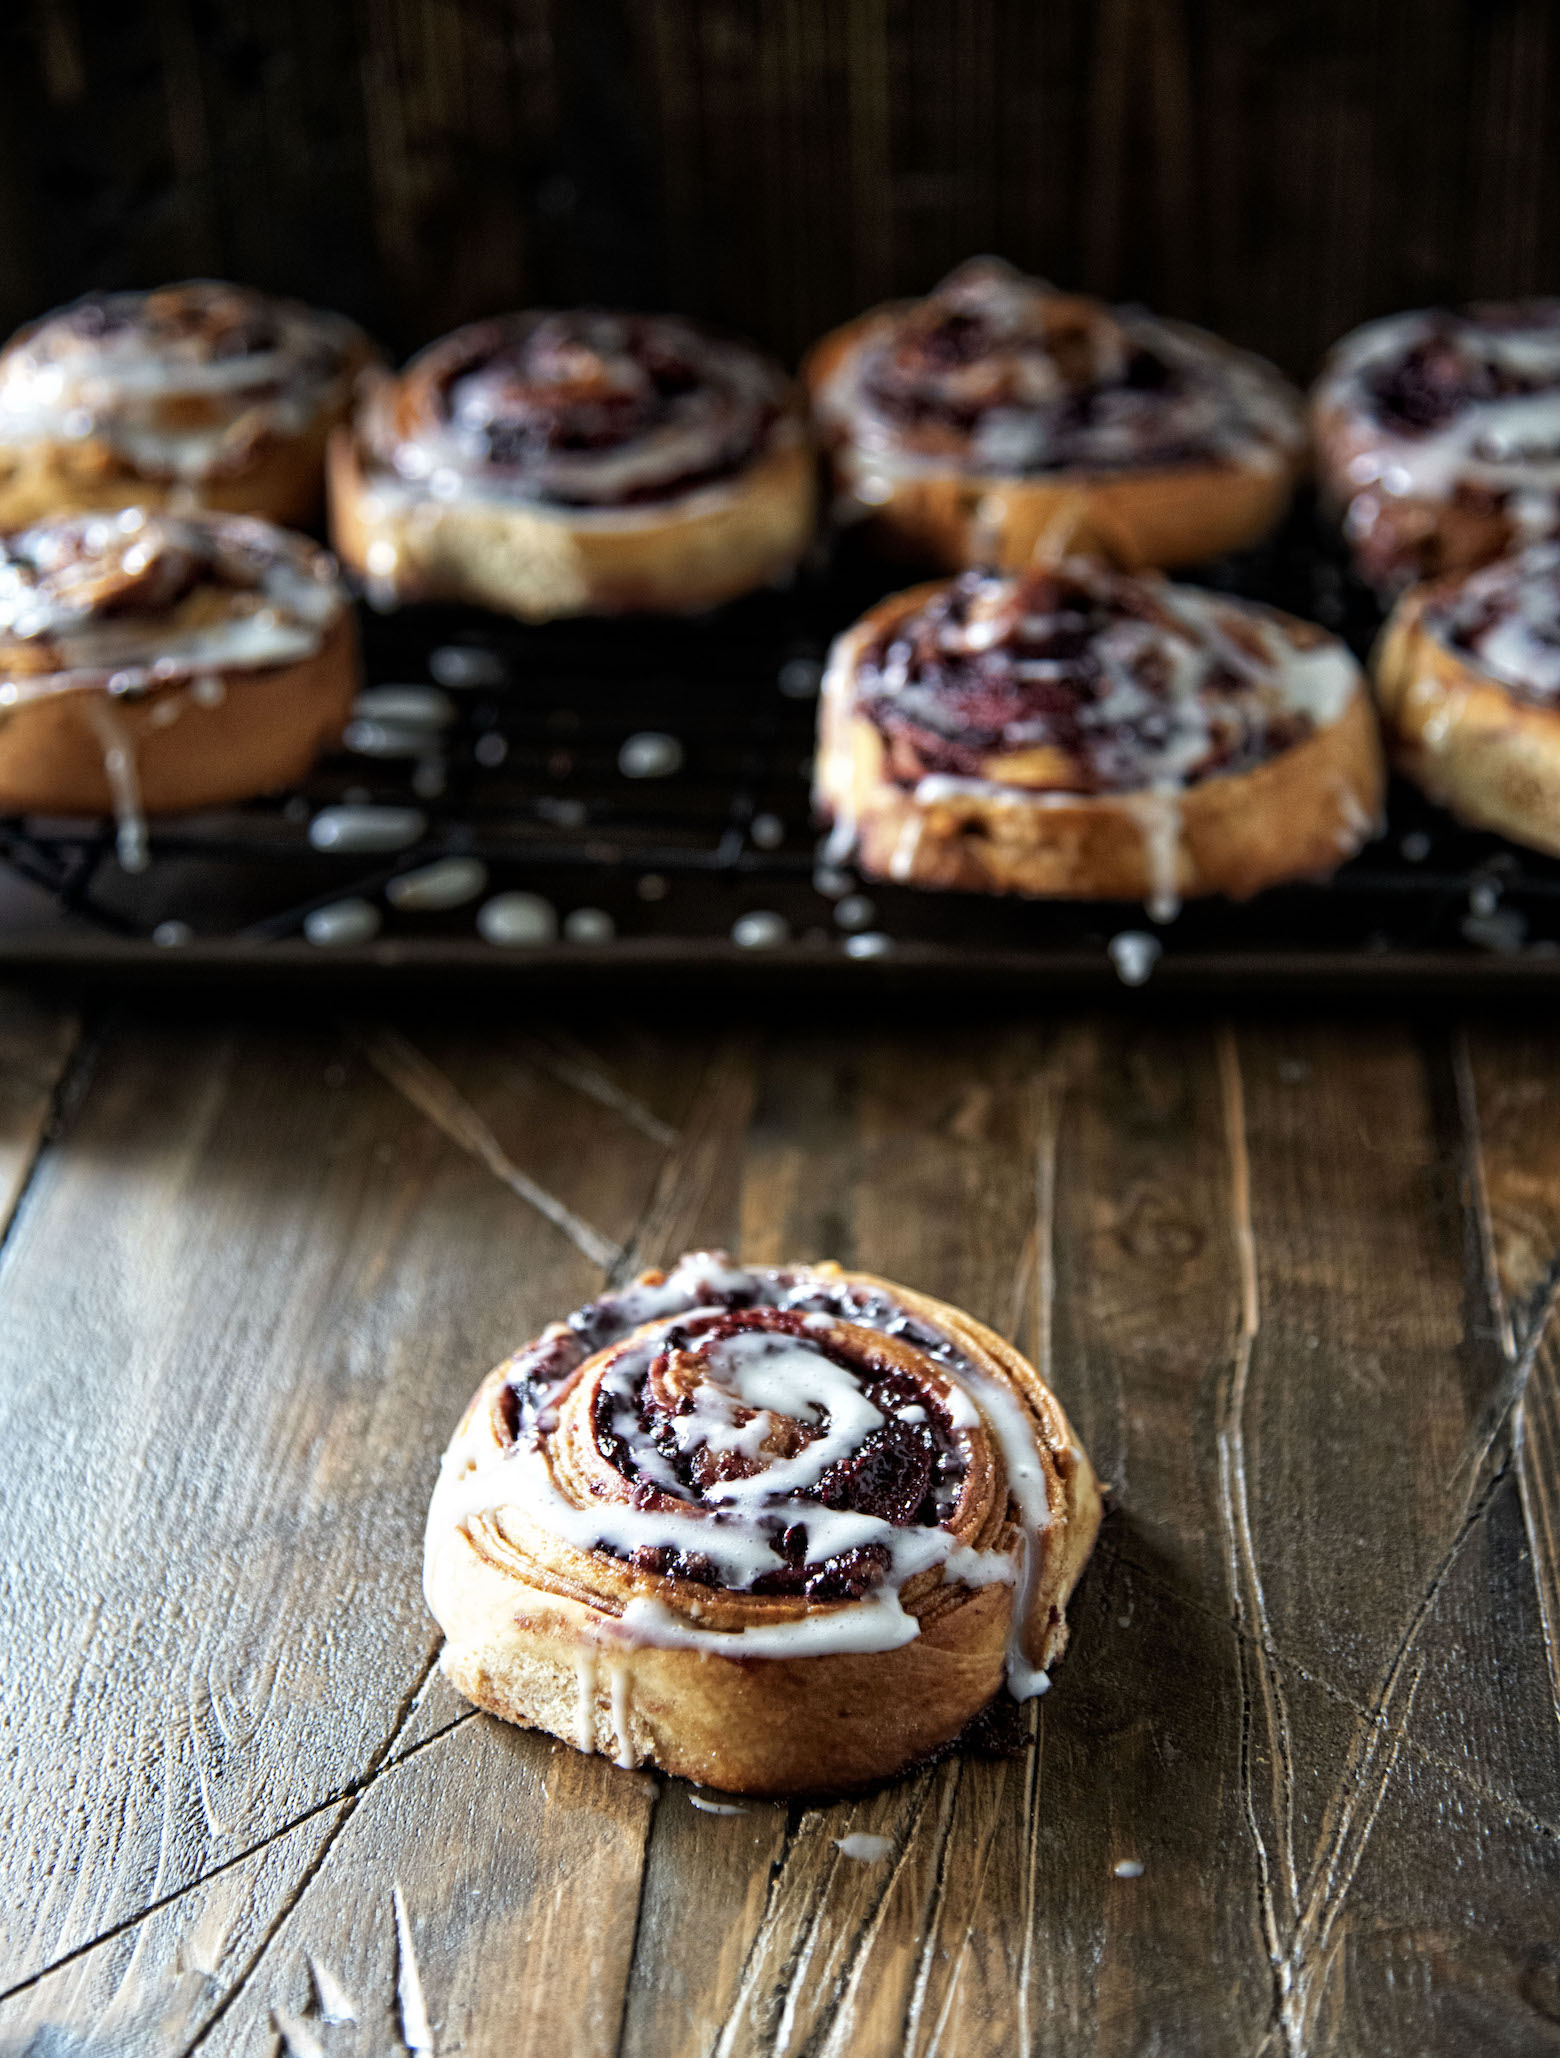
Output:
top-left (805, 257), bottom-right (1305, 570)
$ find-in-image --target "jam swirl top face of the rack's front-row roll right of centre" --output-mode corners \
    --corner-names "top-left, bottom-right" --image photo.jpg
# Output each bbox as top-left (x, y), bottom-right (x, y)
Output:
top-left (854, 560), bottom-right (1358, 794)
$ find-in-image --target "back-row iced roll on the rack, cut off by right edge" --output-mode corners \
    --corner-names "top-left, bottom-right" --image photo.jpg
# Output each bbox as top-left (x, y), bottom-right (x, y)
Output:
top-left (1311, 300), bottom-right (1560, 589)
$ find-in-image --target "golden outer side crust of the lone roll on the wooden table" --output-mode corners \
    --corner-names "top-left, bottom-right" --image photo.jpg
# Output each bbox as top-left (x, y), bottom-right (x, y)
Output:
top-left (426, 1266), bottom-right (1101, 1795)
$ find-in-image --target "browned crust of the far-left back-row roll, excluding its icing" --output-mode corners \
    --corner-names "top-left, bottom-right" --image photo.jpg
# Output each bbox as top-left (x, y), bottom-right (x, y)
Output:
top-left (0, 280), bottom-right (377, 531)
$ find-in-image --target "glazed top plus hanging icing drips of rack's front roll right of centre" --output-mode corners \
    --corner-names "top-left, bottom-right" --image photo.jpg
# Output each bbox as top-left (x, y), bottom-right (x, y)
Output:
top-left (831, 560), bottom-right (1362, 876)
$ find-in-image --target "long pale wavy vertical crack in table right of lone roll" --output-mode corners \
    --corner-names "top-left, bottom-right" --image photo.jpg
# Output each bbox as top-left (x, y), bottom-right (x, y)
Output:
top-left (1218, 1023), bottom-right (1299, 2052)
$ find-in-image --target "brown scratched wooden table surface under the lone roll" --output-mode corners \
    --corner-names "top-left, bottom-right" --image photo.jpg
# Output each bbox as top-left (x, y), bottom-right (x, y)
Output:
top-left (0, 996), bottom-right (1560, 2058)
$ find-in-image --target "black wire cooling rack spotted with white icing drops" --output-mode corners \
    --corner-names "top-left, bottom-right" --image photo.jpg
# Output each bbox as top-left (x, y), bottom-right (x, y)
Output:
top-left (0, 506), bottom-right (1560, 994)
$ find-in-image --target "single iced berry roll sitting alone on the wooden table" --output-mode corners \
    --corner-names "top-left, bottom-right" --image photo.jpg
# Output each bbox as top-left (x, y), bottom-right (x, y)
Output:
top-left (424, 1253), bottom-right (1099, 1795)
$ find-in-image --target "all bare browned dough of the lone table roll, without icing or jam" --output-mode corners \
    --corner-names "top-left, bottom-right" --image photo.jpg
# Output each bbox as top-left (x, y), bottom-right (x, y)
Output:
top-left (426, 1262), bottom-right (1101, 1795)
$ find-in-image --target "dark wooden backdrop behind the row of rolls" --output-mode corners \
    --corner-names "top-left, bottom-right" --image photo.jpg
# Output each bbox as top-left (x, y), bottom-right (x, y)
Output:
top-left (0, 0), bottom-right (1560, 375)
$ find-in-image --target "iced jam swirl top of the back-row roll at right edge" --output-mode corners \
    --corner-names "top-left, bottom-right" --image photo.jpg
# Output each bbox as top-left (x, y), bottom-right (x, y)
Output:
top-left (1317, 300), bottom-right (1560, 539)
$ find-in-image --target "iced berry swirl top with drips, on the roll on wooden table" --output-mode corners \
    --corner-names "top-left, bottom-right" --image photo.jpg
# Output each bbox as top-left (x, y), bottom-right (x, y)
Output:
top-left (428, 1251), bottom-right (1050, 1704)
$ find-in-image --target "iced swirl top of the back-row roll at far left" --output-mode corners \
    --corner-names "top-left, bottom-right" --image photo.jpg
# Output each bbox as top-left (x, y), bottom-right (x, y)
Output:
top-left (0, 280), bottom-right (366, 484)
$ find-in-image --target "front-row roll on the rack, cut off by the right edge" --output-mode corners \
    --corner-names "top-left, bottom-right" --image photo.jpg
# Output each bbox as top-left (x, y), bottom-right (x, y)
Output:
top-left (1373, 541), bottom-right (1560, 856)
